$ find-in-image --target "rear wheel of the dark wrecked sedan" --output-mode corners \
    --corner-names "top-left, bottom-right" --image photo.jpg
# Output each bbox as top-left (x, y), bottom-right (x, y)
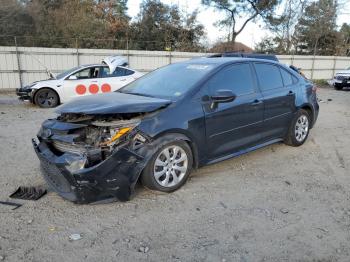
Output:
top-left (284, 109), bottom-right (311, 146)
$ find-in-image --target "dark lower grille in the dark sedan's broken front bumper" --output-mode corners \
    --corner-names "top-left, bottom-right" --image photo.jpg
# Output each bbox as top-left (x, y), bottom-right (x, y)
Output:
top-left (38, 154), bottom-right (71, 193)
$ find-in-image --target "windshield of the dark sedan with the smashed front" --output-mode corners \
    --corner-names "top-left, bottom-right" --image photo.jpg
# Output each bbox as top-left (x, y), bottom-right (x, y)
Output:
top-left (118, 62), bottom-right (214, 100)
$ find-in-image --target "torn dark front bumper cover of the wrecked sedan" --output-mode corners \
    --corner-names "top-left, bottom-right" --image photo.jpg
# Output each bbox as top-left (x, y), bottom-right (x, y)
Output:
top-left (32, 139), bottom-right (144, 204)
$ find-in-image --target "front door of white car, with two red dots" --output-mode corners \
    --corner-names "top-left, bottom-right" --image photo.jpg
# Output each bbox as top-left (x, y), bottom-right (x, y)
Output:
top-left (61, 66), bottom-right (101, 103)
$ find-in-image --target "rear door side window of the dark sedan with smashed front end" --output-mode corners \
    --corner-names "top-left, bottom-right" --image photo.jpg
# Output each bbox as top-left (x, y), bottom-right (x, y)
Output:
top-left (254, 63), bottom-right (283, 91)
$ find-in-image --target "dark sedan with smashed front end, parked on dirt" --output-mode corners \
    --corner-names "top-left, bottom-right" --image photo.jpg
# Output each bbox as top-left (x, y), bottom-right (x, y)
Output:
top-left (33, 58), bottom-right (318, 203)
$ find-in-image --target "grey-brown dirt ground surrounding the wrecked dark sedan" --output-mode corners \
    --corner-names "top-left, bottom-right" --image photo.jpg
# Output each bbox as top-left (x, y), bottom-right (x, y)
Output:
top-left (0, 88), bottom-right (350, 261)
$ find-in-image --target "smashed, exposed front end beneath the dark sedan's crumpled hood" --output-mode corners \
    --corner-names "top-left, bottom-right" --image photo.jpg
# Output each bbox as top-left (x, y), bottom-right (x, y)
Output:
top-left (38, 114), bottom-right (147, 168)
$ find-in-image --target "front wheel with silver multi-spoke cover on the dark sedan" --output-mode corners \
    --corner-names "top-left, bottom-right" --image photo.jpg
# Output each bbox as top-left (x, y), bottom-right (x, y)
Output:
top-left (141, 140), bottom-right (193, 192)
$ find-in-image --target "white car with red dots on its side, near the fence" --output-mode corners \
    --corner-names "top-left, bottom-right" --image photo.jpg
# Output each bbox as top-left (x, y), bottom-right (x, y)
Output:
top-left (16, 56), bottom-right (143, 108)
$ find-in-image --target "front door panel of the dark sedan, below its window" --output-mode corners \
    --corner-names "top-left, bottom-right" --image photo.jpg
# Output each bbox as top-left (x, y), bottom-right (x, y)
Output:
top-left (204, 93), bottom-right (264, 159)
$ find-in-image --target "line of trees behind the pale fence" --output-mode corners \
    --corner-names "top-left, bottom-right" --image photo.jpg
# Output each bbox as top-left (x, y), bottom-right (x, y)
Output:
top-left (0, 0), bottom-right (350, 55)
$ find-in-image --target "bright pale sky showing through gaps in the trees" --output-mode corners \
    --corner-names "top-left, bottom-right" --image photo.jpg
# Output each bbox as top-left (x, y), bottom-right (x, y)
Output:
top-left (128, 0), bottom-right (350, 47)
